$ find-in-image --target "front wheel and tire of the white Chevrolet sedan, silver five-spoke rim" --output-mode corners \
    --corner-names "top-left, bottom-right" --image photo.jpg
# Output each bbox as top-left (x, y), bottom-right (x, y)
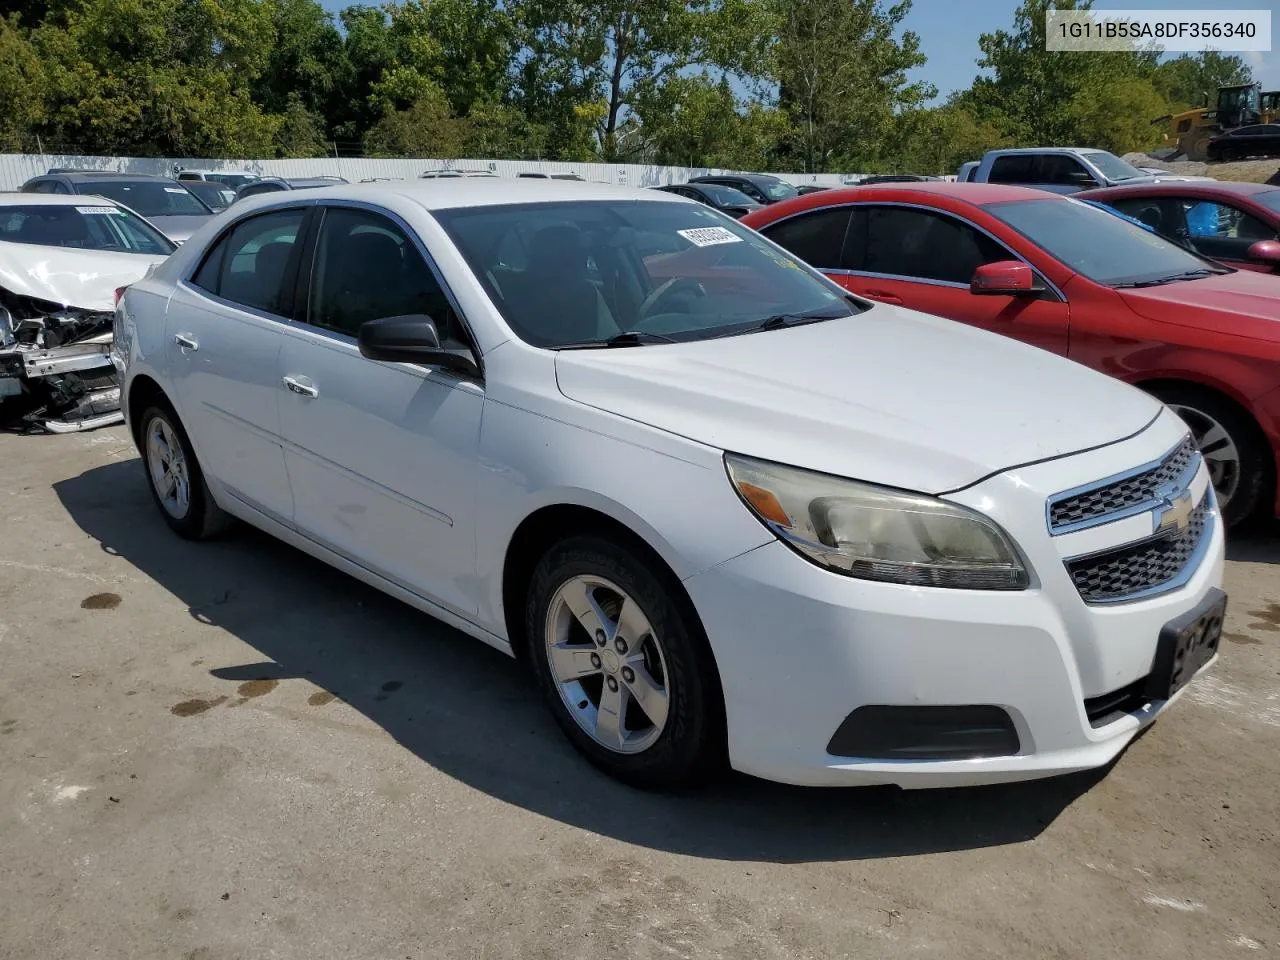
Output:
top-left (525, 536), bottom-right (724, 790)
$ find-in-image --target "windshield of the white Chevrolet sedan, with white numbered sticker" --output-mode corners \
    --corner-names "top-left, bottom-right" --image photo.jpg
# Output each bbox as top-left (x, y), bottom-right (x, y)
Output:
top-left (435, 200), bottom-right (854, 348)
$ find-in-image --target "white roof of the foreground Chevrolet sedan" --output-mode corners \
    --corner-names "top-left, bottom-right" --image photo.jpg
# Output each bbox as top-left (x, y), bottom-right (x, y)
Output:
top-left (238, 177), bottom-right (694, 210)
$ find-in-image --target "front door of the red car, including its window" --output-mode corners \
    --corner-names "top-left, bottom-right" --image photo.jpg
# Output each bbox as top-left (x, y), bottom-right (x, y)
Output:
top-left (841, 204), bottom-right (1070, 356)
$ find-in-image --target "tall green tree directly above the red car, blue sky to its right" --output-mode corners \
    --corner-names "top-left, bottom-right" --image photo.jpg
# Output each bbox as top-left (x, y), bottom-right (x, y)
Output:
top-left (773, 0), bottom-right (936, 172)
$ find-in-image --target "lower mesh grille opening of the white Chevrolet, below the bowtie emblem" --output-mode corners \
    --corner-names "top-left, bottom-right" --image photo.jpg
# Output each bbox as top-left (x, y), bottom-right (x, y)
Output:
top-left (1066, 492), bottom-right (1210, 603)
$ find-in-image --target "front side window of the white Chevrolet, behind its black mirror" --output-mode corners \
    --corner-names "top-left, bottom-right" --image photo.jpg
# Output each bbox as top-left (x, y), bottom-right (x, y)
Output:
top-left (307, 207), bottom-right (467, 347)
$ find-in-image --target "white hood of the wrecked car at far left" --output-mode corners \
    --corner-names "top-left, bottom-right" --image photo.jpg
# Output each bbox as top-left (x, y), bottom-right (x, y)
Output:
top-left (0, 242), bottom-right (164, 310)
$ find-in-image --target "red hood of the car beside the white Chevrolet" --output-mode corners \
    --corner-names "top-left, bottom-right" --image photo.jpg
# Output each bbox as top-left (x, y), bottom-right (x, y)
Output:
top-left (1116, 270), bottom-right (1280, 344)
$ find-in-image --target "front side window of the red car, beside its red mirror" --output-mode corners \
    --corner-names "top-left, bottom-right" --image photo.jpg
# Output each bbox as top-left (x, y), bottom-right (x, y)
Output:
top-left (861, 206), bottom-right (1012, 285)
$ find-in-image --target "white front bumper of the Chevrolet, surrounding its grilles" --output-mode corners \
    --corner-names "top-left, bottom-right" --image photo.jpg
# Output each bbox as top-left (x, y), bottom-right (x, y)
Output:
top-left (685, 415), bottom-right (1224, 787)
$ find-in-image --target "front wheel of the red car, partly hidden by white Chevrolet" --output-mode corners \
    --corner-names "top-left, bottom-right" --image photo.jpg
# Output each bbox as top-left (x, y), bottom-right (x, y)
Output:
top-left (1152, 384), bottom-right (1274, 527)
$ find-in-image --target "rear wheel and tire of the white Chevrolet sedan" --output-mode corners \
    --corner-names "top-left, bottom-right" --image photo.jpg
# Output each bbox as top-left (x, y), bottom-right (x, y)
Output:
top-left (138, 403), bottom-right (230, 540)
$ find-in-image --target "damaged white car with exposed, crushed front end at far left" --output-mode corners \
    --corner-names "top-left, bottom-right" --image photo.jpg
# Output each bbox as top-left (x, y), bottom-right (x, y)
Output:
top-left (0, 193), bottom-right (175, 433)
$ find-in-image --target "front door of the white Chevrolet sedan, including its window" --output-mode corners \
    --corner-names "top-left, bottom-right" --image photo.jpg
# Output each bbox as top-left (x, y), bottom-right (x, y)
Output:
top-left (276, 206), bottom-right (484, 614)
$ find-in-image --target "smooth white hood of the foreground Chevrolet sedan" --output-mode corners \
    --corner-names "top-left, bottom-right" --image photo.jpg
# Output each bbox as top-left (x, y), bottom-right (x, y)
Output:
top-left (556, 305), bottom-right (1160, 493)
